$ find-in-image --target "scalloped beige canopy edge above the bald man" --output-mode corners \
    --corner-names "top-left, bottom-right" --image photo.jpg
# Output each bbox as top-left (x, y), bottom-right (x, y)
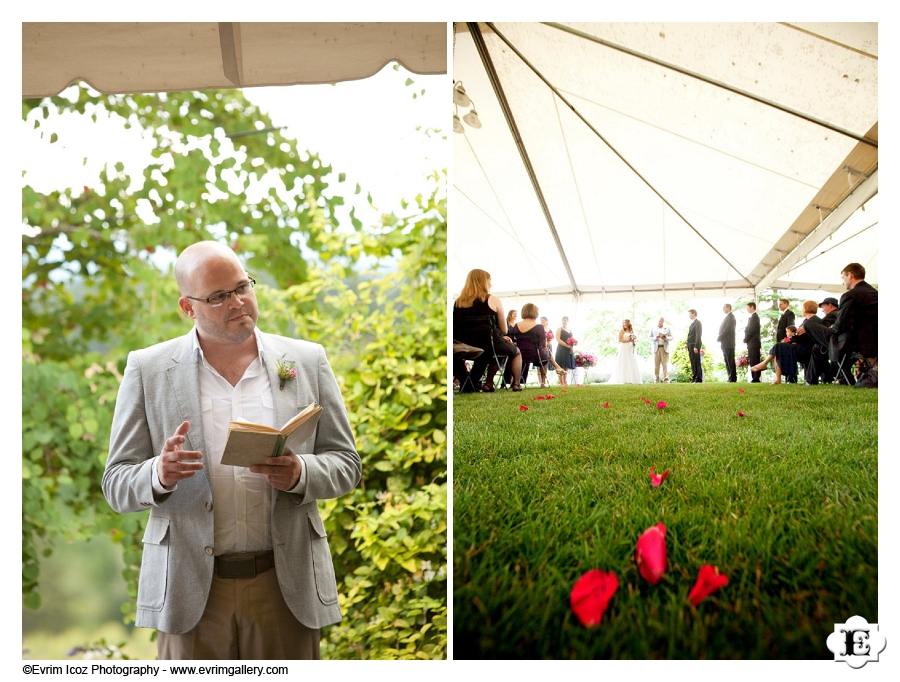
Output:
top-left (22, 22), bottom-right (447, 98)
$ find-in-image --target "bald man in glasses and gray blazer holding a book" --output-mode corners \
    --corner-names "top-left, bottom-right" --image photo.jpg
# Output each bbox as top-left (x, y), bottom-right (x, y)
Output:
top-left (102, 242), bottom-right (361, 659)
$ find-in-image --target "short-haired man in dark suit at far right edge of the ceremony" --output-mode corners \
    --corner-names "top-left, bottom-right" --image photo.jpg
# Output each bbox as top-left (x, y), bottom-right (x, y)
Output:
top-left (829, 263), bottom-right (878, 388)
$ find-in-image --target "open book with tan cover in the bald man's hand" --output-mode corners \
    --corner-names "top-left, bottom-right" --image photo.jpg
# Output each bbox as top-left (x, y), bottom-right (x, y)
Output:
top-left (222, 403), bottom-right (322, 467)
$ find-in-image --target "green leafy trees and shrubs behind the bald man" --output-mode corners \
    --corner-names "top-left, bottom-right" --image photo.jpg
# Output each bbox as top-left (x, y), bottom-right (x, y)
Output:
top-left (22, 89), bottom-right (447, 658)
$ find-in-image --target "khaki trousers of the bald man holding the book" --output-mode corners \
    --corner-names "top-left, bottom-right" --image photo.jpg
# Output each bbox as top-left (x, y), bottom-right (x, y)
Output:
top-left (156, 568), bottom-right (319, 660)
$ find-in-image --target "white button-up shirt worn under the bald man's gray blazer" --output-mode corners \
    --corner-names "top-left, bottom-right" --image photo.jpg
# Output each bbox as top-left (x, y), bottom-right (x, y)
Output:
top-left (153, 329), bottom-right (304, 556)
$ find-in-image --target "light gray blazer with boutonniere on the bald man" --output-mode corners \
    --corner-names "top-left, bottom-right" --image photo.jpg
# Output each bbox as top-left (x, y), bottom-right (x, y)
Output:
top-left (102, 330), bottom-right (362, 634)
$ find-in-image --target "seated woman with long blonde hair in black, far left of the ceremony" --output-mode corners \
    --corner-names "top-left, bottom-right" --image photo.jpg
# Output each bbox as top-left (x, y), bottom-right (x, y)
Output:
top-left (453, 269), bottom-right (522, 393)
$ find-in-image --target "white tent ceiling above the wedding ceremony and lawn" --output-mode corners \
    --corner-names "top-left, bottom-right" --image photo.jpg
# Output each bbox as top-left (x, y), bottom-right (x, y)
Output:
top-left (449, 23), bottom-right (877, 295)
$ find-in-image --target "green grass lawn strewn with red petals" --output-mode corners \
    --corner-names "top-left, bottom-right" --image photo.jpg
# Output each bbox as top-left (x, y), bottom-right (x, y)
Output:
top-left (453, 384), bottom-right (878, 659)
